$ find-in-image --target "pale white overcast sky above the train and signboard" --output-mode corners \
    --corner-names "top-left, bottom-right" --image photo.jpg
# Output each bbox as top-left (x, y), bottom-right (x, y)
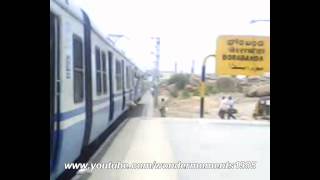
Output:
top-left (71, 0), bottom-right (270, 73)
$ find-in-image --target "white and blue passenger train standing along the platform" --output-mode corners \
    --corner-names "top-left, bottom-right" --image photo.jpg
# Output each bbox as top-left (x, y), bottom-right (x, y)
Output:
top-left (50, 0), bottom-right (144, 179)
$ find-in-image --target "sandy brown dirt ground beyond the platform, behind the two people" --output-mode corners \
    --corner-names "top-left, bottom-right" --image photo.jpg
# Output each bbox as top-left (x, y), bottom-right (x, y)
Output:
top-left (155, 93), bottom-right (259, 120)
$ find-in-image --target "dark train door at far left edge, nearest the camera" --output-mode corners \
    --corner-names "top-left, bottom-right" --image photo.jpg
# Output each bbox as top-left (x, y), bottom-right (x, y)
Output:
top-left (50, 13), bottom-right (60, 170)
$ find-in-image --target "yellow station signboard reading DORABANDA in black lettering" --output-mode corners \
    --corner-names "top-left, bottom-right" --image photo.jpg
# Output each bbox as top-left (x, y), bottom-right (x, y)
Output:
top-left (216, 36), bottom-right (270, 76)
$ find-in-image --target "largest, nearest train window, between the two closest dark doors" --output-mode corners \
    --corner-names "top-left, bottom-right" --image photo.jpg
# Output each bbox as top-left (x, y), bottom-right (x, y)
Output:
top-left (73, 35), bottom-right (84, 103)
